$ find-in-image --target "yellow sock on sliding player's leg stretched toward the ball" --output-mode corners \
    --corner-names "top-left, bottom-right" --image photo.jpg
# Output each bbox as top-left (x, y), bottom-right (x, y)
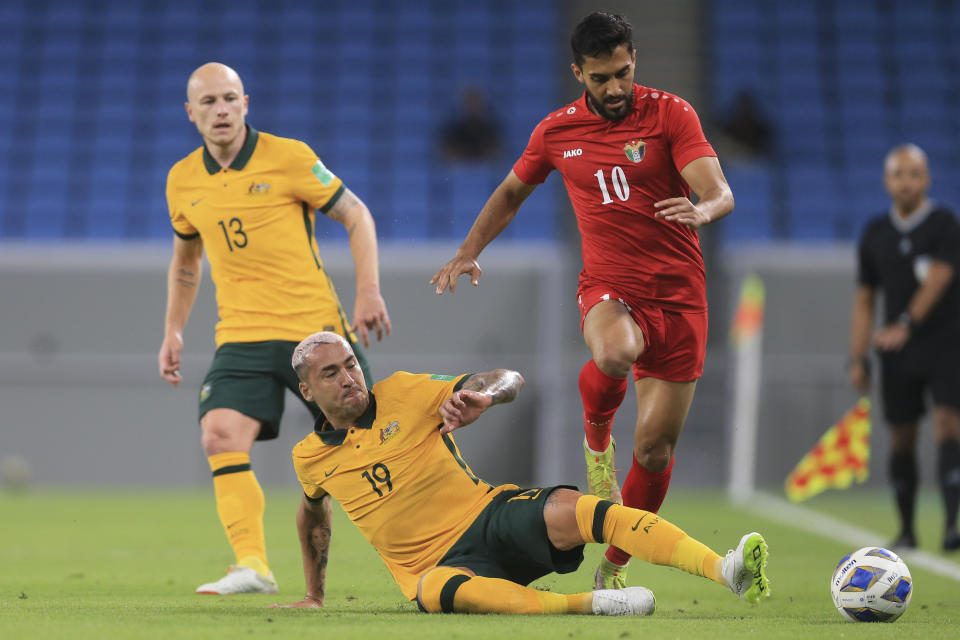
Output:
top-left (576, 495), bottom-right (726, 584)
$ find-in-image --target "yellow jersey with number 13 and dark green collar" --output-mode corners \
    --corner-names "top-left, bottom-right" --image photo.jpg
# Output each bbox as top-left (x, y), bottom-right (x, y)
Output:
top-left (167, 125), bottom-right (349, 347)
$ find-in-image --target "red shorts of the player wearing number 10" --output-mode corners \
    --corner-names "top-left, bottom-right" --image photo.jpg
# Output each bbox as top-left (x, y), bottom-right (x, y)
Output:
top-left (577, 282), bottom-right (707, 382)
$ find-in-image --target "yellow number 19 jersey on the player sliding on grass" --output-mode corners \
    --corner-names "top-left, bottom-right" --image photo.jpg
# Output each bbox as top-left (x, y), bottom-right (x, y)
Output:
top-left (293, 371), bottom-right (516, 599)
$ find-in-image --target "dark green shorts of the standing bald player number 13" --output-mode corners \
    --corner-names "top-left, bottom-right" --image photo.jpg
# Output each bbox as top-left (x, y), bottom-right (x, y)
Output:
top-left (199, 340), bottom-right (373, 440)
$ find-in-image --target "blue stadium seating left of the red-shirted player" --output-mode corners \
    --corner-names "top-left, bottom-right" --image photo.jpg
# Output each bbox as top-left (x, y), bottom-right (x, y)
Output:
top-left (0, 0), bottom-right (565, 241)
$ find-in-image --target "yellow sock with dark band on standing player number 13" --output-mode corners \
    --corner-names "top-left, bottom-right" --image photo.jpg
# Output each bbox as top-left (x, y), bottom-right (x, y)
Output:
top-left (208, 451), bottom-right (270, 575)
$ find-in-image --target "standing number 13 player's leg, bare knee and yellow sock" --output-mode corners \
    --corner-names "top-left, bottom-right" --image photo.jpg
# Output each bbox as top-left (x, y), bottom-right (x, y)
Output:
top-left (200, 408), bottom-right (270, 575)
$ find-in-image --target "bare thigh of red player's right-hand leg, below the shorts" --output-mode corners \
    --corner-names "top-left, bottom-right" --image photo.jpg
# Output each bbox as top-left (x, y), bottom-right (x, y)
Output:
top-left (634, 378), bottom-right (697, 444)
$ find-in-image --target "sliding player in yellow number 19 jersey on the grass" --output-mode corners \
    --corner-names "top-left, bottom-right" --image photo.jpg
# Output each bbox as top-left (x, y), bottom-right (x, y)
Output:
top-left (272, 332), bottom-right (770, 615)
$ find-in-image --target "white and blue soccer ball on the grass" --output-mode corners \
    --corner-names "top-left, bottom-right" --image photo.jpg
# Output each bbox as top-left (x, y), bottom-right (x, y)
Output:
top-left (830, 547), bottom-right (913, 622)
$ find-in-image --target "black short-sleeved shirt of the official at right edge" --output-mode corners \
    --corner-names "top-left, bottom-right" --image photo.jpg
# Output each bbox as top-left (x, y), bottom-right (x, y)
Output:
top-left (857, 201), bottom-right (960, 349)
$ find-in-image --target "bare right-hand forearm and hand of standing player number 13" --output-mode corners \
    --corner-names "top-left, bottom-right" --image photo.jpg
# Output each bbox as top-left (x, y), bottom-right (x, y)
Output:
top-left (327, 189), bottom-right (391, 347)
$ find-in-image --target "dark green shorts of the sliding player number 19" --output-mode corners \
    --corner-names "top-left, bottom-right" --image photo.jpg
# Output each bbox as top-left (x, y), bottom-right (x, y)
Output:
top-left (438, 485), bottom-right (583, 585)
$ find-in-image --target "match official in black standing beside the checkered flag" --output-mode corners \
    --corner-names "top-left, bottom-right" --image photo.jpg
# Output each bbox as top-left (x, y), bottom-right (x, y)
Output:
top-left (848, 144), bottom-right (960, 551)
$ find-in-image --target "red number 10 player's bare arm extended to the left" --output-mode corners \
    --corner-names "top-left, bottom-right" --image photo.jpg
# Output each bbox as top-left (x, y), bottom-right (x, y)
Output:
top-left (430, 170), bottom-right (537, 295)
